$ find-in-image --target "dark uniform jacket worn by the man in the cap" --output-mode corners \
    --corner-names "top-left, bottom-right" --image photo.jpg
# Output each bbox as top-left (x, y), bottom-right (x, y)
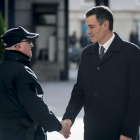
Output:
top-left (0, 50), bottom-right (62, 140)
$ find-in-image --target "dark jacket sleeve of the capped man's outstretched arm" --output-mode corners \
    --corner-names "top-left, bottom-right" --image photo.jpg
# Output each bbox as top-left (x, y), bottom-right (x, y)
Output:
top-left (17, 71), bottom-right (62, 132)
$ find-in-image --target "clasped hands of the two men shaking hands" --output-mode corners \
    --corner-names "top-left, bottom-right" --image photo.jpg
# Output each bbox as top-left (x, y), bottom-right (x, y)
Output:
top-left (59, 119), bottom-right (72, 139)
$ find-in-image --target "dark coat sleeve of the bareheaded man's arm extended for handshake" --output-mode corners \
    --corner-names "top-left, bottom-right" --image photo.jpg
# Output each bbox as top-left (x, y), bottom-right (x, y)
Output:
top-left (63, 59), bottom-right (85, 123)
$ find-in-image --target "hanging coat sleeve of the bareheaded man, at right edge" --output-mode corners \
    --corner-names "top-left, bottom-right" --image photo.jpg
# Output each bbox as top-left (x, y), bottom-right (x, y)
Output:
top-left (121, 48), bottom-right (140, 138)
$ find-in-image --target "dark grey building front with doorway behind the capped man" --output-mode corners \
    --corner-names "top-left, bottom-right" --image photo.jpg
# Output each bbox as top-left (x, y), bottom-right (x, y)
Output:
top-left (0, 0), bottom-right (68, 81)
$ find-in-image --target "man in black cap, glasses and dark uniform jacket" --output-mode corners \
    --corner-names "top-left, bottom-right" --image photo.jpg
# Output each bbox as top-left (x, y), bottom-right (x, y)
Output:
top-left (0, 26), bottom-right (69, 140)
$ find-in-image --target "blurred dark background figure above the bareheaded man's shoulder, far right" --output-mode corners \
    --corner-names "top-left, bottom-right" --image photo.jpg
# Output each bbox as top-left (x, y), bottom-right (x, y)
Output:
top-left (129, 31), bottom-right (140, 47)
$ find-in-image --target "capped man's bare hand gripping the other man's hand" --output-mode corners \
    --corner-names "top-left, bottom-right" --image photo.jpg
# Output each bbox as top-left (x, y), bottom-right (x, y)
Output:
top-left (59, 121), bottom-right (71, 139)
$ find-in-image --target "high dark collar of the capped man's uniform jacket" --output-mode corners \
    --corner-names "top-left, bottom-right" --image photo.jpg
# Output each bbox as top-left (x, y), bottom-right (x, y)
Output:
top-left (4, 50), bottom-right (31, 67)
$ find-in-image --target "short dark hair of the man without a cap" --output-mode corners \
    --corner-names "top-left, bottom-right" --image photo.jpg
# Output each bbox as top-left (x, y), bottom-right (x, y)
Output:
top-left (85, 6), bottom-right (114, 31)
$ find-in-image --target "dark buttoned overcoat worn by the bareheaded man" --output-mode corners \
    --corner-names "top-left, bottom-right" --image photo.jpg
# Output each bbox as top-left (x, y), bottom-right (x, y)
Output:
top-left (63, 33), bottom-right (140, 140)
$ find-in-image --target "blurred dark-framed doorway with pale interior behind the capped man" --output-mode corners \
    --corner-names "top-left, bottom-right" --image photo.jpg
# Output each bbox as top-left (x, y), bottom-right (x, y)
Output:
top-left (33, 3), bottom-right (58, 62)
